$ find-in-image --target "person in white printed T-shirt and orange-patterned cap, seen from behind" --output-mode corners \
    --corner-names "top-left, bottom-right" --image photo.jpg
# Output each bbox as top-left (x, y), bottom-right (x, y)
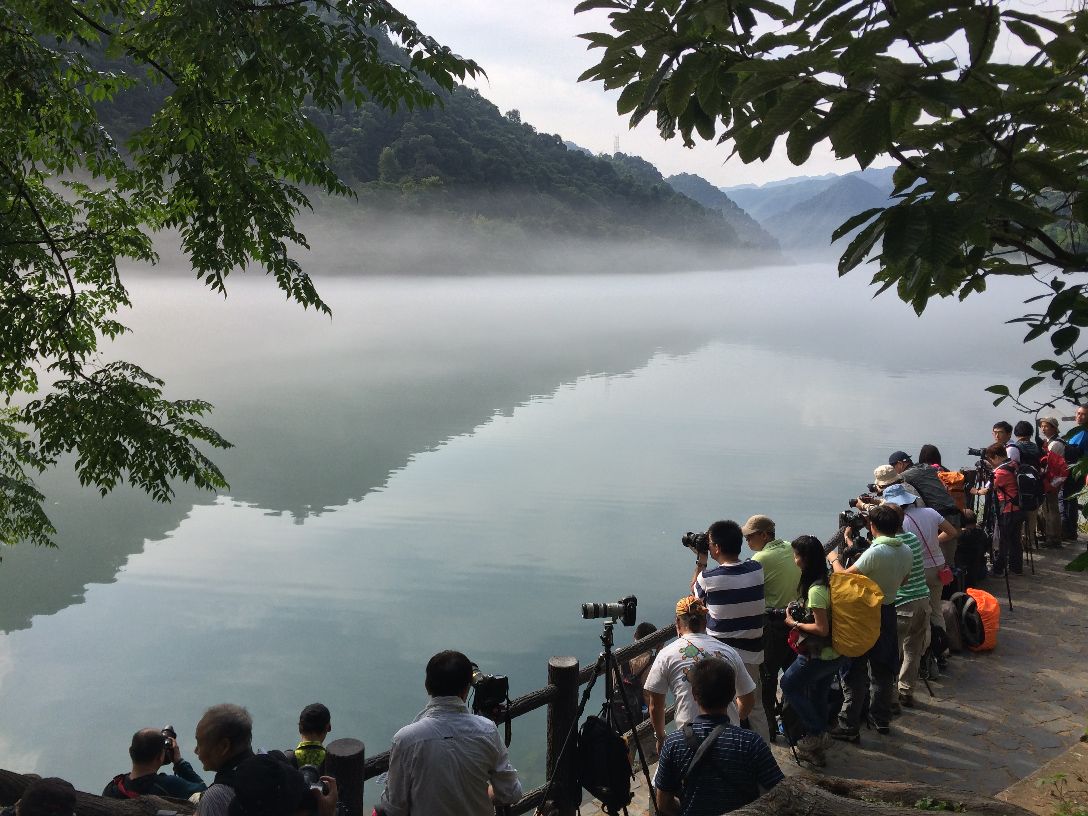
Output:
top-left (645, 595), bottom-right (755, 753)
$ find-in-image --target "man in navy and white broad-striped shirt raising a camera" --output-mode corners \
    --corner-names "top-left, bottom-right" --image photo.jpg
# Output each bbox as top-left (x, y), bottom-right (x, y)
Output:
top-left (691, 521), bottom-right (770, 740)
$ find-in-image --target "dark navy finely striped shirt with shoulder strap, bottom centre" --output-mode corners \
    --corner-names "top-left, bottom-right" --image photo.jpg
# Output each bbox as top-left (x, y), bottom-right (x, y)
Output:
top-left (654, 714), bottom-right (783, 816)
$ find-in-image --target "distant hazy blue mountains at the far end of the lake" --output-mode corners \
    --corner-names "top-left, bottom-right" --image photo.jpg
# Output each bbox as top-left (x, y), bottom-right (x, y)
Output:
top-left (763, 174), bottom-right (888, 251)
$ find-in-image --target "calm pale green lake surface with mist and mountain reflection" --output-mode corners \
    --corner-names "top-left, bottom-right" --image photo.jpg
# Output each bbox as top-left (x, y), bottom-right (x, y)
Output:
top-left (0, 263), bottom-right (1046, 801)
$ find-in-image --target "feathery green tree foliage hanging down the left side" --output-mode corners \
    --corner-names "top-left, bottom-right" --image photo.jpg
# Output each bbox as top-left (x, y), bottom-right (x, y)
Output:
top-left (0, 0), bottom-right (480, 552)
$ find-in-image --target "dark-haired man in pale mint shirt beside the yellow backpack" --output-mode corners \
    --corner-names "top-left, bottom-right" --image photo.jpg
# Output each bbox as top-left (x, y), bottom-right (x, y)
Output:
top-left (828, 505), bottom-right (913, 742)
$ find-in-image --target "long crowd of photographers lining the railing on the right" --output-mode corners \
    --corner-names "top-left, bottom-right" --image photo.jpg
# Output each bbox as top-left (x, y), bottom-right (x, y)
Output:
top-left (642, 417), bottom-right (1088, 814)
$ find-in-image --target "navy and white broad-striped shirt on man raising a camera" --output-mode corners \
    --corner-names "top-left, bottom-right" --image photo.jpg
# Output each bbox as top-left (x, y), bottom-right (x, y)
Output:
top-left (691, 559), bottom-right (764, 666)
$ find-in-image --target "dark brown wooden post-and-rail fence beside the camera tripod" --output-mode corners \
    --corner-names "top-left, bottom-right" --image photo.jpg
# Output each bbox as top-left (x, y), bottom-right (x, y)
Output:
top-left (363, 626), bottom-right (676, 816)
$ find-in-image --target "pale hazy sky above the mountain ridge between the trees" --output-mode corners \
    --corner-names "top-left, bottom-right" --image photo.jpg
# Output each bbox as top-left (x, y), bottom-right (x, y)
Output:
top-left (395, 0), bottom-right (887, 186)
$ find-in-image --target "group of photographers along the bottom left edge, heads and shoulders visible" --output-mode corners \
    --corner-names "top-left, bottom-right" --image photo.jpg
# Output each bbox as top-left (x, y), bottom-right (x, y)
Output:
top-left (0, 651), bottom-right (522, 816)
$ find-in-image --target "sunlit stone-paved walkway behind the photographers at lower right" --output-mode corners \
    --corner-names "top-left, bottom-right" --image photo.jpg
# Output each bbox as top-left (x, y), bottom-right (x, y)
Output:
top-left (582, 541), bottom-right (1088, 816)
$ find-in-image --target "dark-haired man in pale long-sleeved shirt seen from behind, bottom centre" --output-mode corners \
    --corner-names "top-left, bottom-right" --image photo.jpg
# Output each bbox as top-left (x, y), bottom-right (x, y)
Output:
top-left (376, 651), bottom-right (521, 816)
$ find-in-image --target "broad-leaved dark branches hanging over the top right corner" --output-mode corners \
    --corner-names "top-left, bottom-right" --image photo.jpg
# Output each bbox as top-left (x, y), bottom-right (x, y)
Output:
top-left (577, 0), bottom-right (1088, 407)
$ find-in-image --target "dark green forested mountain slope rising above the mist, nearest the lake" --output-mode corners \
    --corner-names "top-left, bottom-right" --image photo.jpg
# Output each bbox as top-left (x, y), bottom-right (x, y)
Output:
top-left (94, 34), bottom-right (774, 251)
